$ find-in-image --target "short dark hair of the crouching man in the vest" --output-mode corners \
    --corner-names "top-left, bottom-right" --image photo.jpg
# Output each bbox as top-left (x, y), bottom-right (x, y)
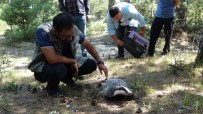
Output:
top-left (53, 12), bottom-right (74, 32)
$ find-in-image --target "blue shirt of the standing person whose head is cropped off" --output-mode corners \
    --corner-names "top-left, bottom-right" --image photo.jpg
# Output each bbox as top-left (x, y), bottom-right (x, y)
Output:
top-left (155, 0), bottom-right (175, 18)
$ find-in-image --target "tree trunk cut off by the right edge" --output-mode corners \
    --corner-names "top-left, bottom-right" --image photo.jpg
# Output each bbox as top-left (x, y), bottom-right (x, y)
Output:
top-left (195, 38), bottom-right (203, 64)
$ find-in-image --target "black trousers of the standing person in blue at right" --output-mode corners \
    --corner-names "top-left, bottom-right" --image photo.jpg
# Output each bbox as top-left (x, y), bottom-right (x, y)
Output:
top-left (148, 17), bottom-right (174, 55)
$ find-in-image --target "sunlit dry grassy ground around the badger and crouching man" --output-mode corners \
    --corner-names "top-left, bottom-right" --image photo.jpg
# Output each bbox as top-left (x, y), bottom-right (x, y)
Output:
top-left (0, 32), bottom-right (203, 114)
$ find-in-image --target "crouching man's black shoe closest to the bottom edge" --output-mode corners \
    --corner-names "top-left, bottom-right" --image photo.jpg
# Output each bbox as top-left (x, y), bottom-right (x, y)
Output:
top-left (45, 87), bottom-right (64, 98)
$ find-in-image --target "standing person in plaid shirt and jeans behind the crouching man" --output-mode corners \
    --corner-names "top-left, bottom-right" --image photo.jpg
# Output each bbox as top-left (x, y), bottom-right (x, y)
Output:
top-left (58, 0), bottom-right (90, 57)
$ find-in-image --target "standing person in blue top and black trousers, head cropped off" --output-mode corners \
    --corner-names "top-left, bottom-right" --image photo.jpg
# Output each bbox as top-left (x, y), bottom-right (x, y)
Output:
top-left (148, 0), bottom-right (179, 57)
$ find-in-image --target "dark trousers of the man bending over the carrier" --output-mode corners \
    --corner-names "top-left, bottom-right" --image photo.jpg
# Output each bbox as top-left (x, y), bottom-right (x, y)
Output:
top-left (116, 26), bottom-right (137, 57)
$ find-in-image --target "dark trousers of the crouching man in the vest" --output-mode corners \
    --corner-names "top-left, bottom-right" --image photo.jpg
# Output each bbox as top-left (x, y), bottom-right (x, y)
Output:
top-left (34, 42), bottom-right (97, 89)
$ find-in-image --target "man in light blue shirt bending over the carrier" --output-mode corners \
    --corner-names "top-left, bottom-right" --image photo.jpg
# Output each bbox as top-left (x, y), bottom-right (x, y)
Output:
top-left (106, 2), bottom-right (145, 59)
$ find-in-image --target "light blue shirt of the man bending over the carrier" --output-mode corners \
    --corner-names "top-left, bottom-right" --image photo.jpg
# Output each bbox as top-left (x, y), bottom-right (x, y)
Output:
top-left (106, 2), bottom-right (145, 35)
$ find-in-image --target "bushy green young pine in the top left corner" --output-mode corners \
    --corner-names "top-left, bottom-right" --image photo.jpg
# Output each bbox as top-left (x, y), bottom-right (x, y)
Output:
top-left (1, 0), bottom-right (38, 30)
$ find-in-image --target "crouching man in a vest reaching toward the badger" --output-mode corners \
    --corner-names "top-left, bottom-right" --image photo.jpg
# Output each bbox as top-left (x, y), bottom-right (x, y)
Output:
top-left (28, 12), bottom-right (108, 96)
